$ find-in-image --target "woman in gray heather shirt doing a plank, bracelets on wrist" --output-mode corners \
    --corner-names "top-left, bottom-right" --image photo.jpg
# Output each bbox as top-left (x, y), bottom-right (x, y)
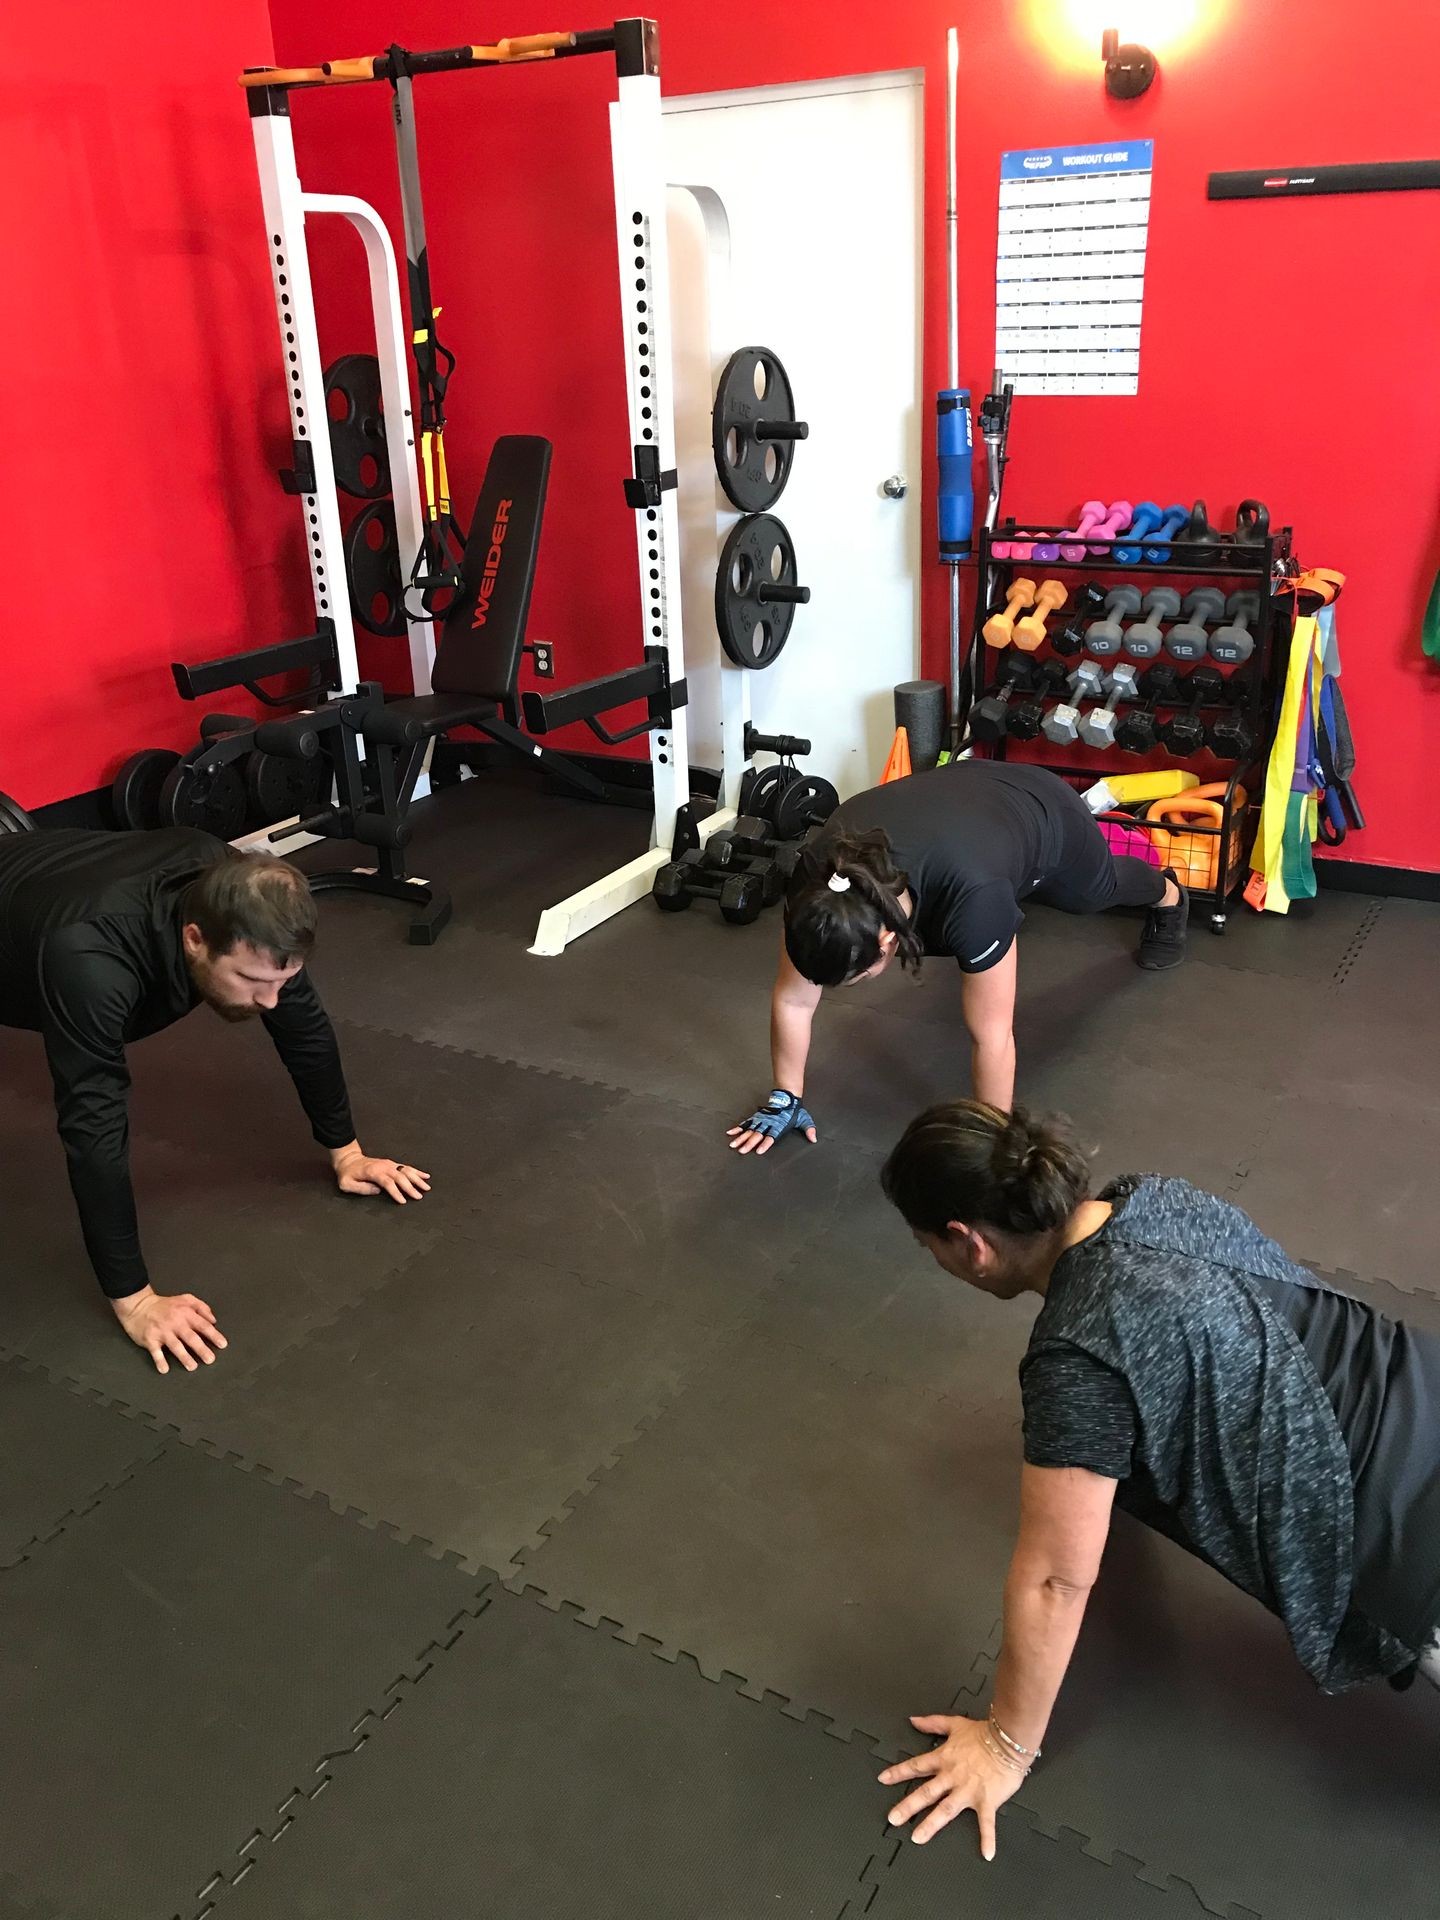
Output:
top-left (867, 1100), bottom-right (1440, 1859)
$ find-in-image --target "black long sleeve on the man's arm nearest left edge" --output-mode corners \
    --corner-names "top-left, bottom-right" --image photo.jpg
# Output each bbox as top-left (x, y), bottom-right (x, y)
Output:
top-left (38, 924), bottom-right (150, 1300)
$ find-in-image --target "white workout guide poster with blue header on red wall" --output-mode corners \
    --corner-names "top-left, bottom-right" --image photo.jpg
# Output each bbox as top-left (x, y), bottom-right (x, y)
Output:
top-left (995, 140), bottom-right (1154, 394)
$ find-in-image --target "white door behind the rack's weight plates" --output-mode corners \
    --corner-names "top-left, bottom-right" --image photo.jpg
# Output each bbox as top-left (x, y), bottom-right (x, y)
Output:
top-left (664, 73), bottom-right (927, 797)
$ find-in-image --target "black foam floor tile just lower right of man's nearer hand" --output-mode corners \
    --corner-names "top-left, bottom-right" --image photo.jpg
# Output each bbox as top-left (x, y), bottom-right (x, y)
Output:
top-left (174, 1235), bottom-right (718, 1565)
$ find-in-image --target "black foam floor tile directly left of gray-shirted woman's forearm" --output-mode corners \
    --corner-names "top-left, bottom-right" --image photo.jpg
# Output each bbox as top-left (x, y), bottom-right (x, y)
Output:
top-left (514, 1338), bottom-right (1020, 1751)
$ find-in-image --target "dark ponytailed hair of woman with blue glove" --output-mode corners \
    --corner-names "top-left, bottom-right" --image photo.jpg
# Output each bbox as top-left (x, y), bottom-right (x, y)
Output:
top-left (785, 828), bottom-right (924, 987)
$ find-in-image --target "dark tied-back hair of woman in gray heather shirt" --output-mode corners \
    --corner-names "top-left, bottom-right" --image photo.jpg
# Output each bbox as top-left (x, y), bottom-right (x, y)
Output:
top-left (879, 1100), bottom-right (1091, 1235)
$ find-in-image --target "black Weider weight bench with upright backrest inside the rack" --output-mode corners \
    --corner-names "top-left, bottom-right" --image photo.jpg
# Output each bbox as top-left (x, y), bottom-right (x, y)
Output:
top-left (247, 434), bottom-right (685, 945)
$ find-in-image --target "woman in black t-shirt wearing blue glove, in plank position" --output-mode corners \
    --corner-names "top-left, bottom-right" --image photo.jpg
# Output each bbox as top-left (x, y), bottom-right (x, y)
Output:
top-left (730, 760), bottom-right (1188, 1154)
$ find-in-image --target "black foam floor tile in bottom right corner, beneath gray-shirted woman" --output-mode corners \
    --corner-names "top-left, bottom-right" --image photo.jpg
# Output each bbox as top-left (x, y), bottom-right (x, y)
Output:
top-left (1021, 1517), bottom-right (1440, 1920)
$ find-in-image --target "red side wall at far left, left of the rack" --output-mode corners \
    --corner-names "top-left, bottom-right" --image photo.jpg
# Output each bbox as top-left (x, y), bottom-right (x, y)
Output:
top-left (0, 0), bottom-right (309, 806)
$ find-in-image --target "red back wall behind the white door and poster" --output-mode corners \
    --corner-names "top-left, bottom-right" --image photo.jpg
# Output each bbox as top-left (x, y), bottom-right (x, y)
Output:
top-left (273, 0), bottom-right (1440, 870)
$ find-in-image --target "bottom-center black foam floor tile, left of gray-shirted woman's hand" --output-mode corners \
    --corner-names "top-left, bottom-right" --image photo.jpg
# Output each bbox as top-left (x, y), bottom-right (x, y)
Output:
top-left (208, 1592), bottom-right (883, 1920)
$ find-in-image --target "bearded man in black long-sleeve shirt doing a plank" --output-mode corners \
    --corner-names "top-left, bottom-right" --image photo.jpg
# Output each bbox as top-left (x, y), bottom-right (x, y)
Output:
top-left (0, 829), bottom-right (430, 1373)
